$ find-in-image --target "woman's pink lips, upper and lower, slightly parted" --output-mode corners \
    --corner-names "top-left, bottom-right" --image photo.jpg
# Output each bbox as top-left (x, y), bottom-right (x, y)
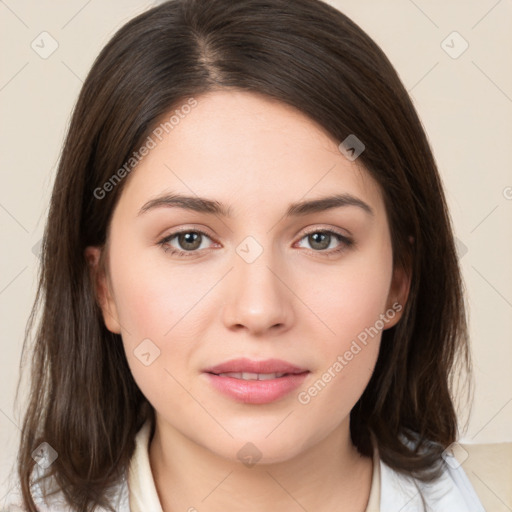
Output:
top-left (204, 359), bottom-right (309, 404)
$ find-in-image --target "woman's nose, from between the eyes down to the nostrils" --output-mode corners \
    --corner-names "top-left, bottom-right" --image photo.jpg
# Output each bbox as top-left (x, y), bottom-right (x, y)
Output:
top-left (222, 243), bottom-right (294, 335)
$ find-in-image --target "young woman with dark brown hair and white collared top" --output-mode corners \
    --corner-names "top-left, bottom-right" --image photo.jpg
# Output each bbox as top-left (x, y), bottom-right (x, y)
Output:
top-left (8, 0), bottom-right (484, 512)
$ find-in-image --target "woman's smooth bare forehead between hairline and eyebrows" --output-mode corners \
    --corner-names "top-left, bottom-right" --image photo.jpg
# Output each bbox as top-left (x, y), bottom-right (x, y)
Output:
top-left (114, 91), bottom-right (383, 215)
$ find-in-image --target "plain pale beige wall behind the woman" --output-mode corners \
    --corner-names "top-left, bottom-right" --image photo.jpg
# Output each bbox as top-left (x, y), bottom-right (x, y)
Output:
top-left (0, 0), bottom-right (512, 510)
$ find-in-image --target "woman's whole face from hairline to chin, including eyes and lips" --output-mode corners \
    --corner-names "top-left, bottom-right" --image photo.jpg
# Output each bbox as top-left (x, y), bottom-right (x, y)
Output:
top-left (87, 91), bottom-right (408, 463)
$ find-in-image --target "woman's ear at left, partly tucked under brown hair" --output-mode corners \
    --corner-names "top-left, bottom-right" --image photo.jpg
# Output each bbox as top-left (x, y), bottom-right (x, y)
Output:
top-left (85, 246), bottom-right (121, 334)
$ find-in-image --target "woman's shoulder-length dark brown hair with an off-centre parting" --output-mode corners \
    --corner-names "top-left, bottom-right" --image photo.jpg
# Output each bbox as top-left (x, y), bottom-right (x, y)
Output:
top-left (12, 0), bottom-right (471, 512)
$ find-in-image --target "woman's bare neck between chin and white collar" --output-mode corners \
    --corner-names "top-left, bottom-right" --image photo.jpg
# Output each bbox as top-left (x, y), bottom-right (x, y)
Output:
top-left (149, 419), bottom-right (373, 512)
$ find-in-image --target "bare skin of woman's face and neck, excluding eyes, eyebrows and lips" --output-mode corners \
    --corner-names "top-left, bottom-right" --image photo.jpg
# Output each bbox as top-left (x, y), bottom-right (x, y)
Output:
top-left (86, 91), bottom-right (409, 512)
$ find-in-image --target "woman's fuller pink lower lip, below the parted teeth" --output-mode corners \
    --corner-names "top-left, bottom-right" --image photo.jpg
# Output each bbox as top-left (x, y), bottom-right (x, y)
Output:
top-left (205, 372), bottom-right (309, 404)
